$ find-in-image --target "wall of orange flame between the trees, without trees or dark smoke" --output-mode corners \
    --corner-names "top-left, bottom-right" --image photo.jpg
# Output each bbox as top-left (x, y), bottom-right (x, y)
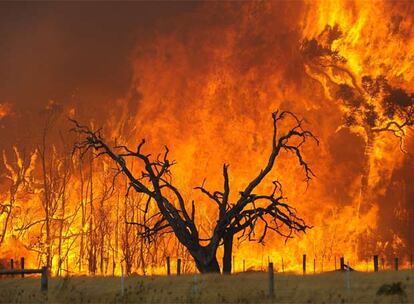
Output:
top-left (0, 1), bottom-right (414, 274)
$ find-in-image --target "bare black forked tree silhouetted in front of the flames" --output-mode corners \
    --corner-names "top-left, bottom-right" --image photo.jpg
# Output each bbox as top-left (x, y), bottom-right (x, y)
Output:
top-left (73, 111), bottom-right (318, 273)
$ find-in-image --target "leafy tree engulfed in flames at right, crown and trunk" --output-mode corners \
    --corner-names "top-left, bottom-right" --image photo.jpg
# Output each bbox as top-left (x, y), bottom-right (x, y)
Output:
top-left (301, 25), bottom-right (414, 262)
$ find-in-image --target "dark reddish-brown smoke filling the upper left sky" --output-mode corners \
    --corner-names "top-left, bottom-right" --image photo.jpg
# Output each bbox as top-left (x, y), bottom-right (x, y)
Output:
top-left (0, 2), bottom-right (201, 148)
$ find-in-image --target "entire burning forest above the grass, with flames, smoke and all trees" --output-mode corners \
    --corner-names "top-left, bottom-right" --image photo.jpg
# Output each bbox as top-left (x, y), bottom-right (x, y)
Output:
top-left (0, 1), bottom-right (414, 276)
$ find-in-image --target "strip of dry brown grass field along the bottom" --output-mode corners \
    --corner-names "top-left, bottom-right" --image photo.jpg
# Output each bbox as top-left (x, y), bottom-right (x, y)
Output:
top-left (0, 270), bottom-right (414, 303)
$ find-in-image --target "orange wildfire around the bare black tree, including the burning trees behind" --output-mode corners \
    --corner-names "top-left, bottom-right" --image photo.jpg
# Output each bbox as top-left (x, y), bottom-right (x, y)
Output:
top-left (0, 1), bottom-right (414, 274)
